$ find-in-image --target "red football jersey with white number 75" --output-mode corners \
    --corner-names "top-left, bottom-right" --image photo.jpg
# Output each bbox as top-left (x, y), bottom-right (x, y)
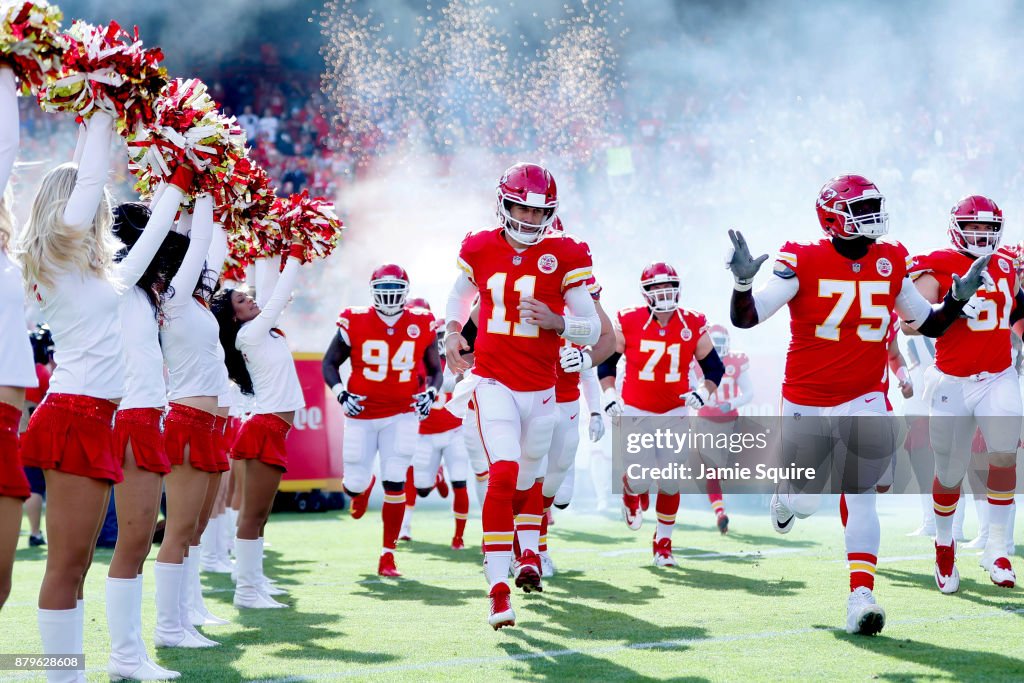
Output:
top-left (775, 239), bottom-right (909, 407)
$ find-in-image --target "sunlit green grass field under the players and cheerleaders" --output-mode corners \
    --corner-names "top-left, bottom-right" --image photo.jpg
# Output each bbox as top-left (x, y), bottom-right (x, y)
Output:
top-left (0, 504), bottom-right (1024, 681)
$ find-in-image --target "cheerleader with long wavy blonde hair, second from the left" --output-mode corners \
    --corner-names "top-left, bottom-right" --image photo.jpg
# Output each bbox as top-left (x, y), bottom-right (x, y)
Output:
top-left (18, 112), bottom-right (182, 680)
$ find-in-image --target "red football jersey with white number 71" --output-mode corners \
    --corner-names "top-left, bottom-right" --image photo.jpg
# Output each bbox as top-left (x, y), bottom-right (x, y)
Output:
top-left (616, 306), bottom-right (708, 414)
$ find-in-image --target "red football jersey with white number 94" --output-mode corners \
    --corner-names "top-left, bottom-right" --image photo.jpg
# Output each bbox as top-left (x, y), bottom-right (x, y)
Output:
top-left (338, 306), bottom-right (437, 420)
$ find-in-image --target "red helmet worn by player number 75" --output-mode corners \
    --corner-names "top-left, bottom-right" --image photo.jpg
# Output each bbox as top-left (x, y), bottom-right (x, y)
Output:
top-left (817, 174), bottom-right (889, 240)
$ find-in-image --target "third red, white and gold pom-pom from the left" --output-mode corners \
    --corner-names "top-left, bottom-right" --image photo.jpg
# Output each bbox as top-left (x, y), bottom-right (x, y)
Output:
top-left (128, 79), bottom-right (246, 197)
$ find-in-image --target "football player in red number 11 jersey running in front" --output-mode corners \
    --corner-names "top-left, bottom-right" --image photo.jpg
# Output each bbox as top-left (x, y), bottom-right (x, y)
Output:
top-left (444, 164), bottom-right (601, 629)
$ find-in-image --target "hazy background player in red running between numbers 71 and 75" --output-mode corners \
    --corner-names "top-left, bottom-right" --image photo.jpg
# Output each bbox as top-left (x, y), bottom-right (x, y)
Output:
top-left (690, 325), bottom-right (754, 535)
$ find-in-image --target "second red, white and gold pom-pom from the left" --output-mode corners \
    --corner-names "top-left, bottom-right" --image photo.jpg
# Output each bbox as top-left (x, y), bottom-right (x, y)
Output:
top-left (39, 20), bottom-right (167, 134)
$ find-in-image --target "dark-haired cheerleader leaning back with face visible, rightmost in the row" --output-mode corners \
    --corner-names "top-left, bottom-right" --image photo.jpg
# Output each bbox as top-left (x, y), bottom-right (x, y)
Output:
top-left (212, 244), bottom-right (305, 608)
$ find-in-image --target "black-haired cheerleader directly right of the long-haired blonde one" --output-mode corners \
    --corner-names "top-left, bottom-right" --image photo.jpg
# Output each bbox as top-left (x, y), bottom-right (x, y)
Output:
top-left (106, 180), bottom-right (191, 680)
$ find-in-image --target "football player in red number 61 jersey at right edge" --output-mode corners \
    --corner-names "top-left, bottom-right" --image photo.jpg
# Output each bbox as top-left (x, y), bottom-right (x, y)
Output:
top-left (910, 195), bottom-right (1024, 593)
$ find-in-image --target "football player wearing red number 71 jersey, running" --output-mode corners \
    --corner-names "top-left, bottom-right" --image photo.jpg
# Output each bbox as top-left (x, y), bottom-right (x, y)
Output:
top-left (598, 262), bottom-right (725, 566)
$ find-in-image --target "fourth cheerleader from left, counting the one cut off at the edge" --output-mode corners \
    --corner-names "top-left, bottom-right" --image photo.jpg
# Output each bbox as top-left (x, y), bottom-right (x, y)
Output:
top-left (154, 195), bottom-right (226, 647)
